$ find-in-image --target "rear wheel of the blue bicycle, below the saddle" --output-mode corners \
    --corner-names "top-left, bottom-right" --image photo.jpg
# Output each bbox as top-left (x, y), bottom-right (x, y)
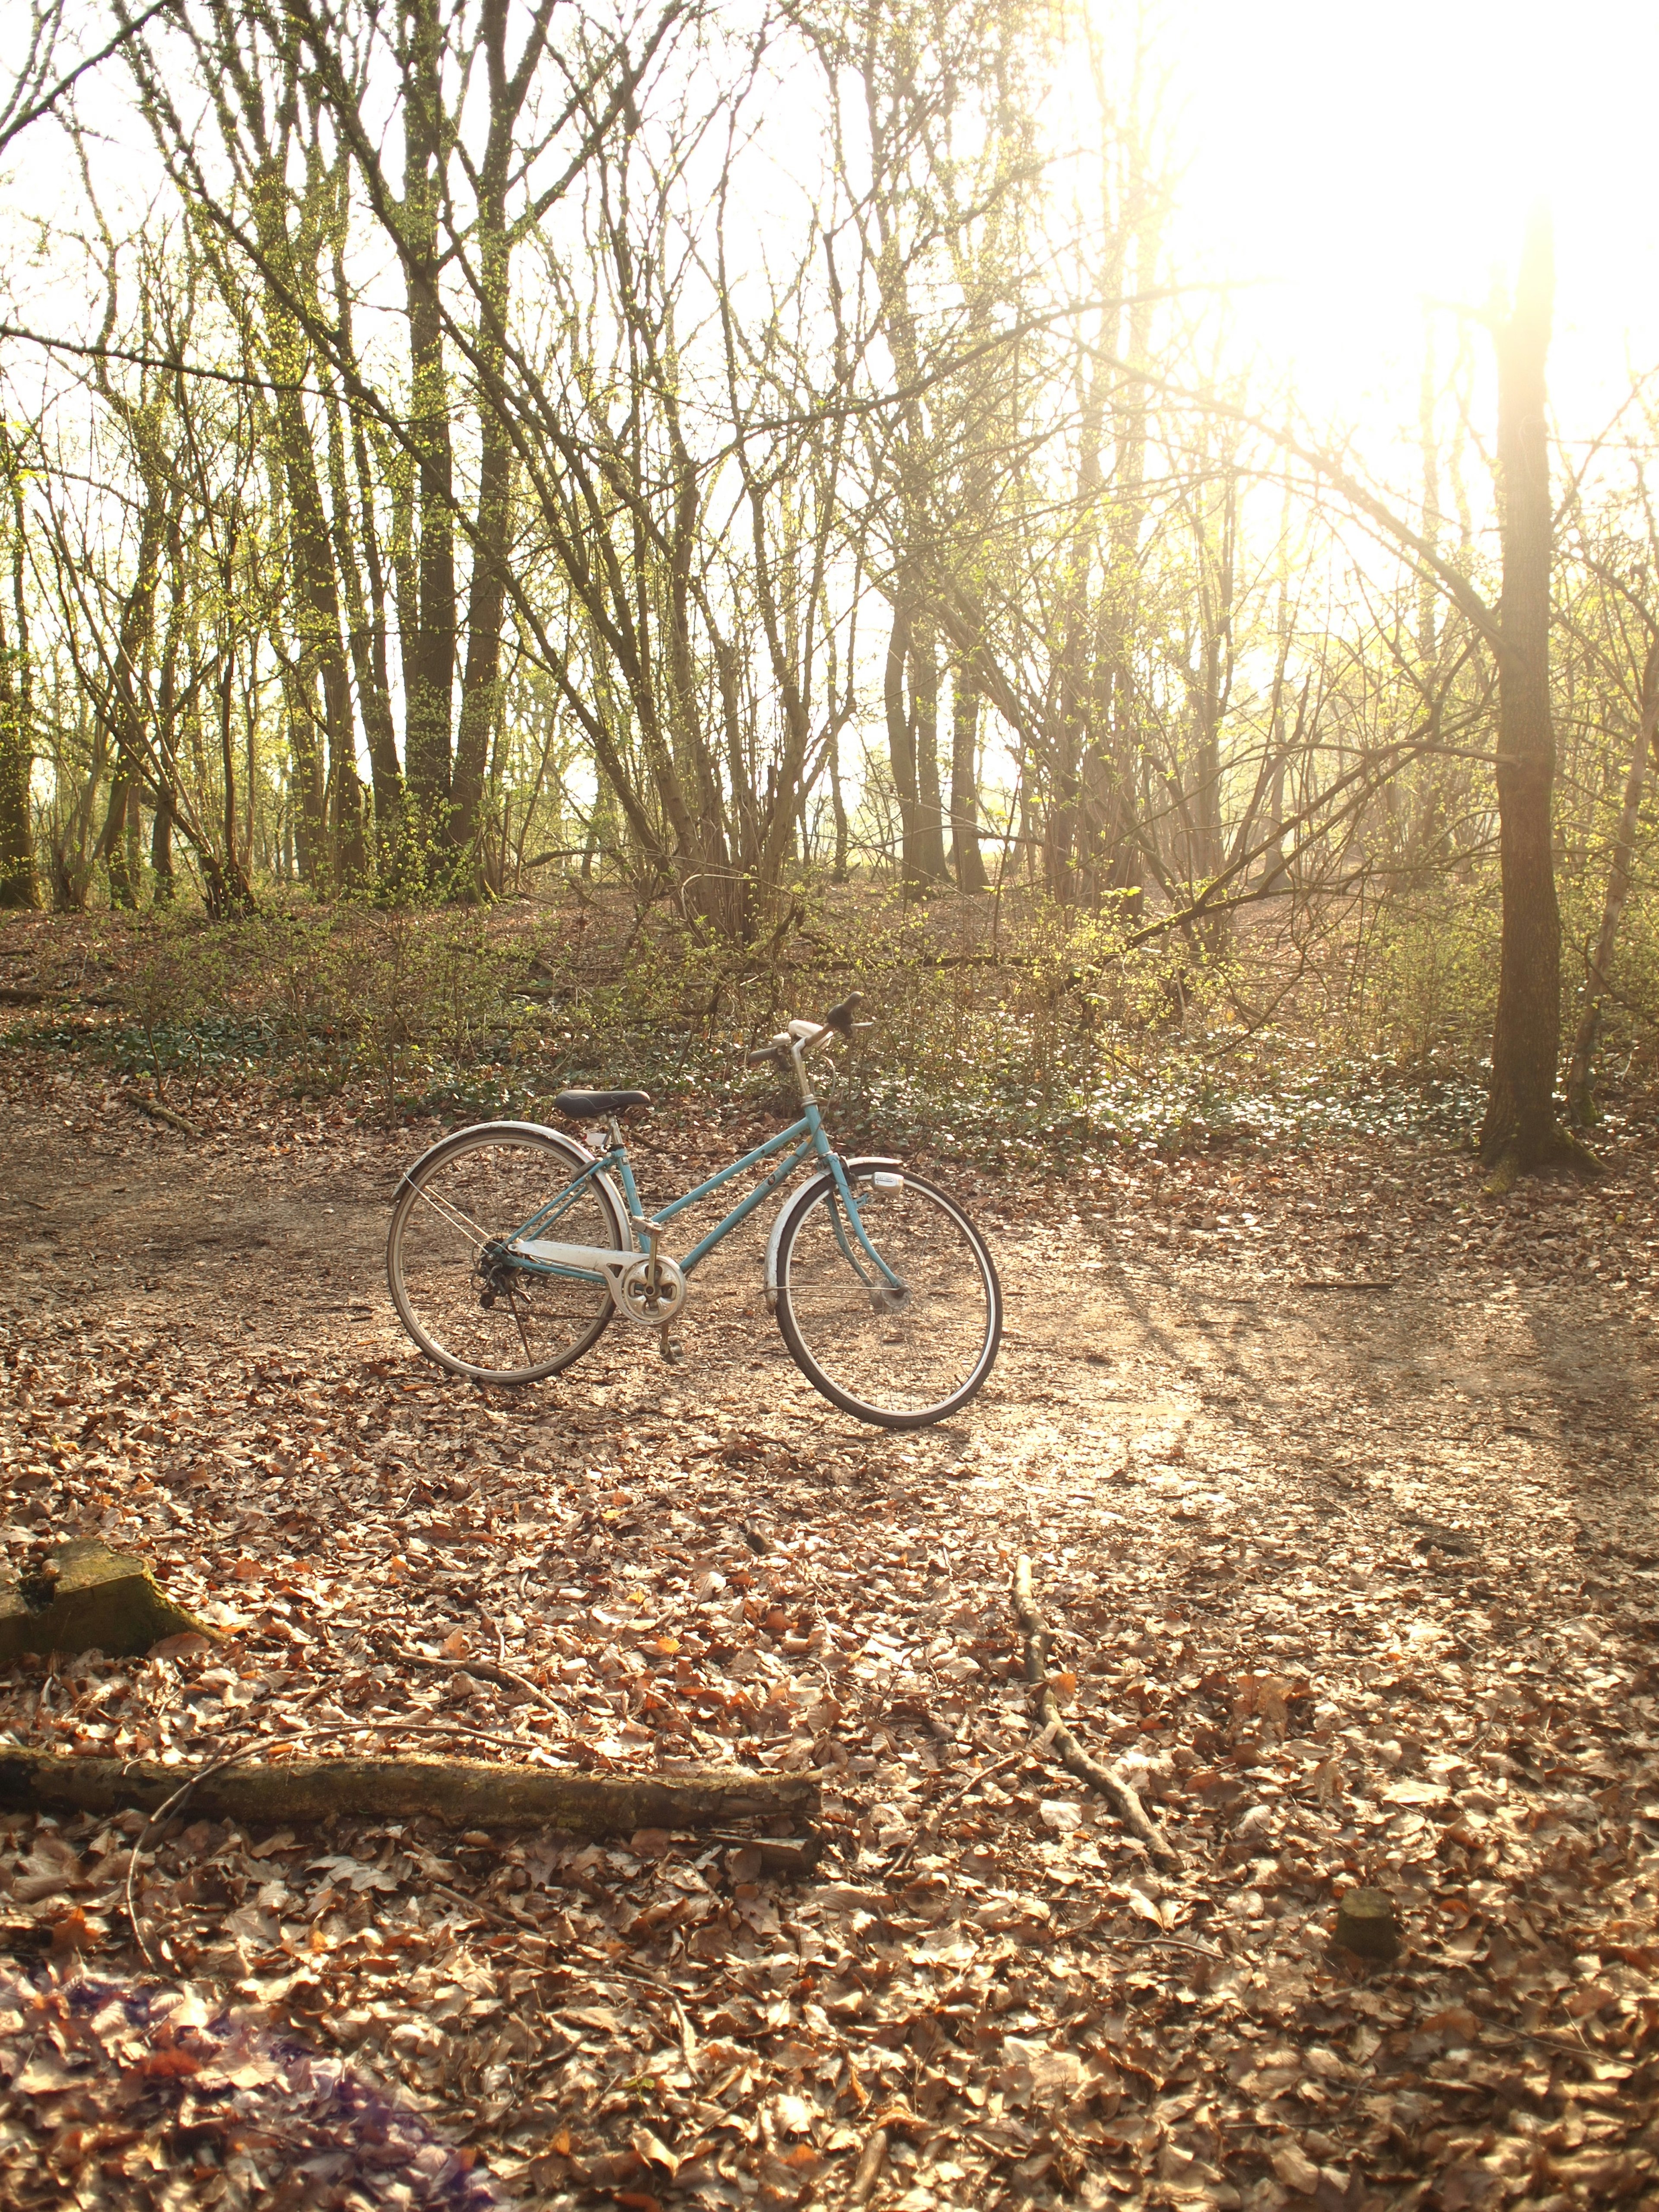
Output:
top-left (387, 1122), bottom-right (632, 1382)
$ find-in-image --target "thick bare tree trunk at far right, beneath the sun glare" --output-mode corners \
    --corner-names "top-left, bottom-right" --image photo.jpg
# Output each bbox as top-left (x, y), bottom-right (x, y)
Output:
top-left (1480, 213), bottom-right (1575, 1185)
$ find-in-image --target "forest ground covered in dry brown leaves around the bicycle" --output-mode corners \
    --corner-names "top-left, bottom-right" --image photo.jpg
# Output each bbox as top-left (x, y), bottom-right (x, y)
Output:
top-left (0, 1051), bottom-right (1659, 2212)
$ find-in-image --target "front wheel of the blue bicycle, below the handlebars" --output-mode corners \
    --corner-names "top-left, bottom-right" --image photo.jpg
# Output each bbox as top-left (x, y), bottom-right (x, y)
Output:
top-left (776, 1168), bottom-right (1002, 1429)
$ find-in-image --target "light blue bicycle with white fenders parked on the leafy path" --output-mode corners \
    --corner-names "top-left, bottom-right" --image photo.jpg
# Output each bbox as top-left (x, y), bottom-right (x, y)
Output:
top-left (387, 993), bottom-right (1002, 1429)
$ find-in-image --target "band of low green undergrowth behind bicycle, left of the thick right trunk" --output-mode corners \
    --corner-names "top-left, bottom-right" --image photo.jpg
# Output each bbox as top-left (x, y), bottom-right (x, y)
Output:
top-left (9, 891), bottom-right (1654, 1170)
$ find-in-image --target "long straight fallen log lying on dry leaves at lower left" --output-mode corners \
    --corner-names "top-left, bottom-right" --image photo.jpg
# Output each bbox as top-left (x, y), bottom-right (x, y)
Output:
top-left (0, 1750), bottom-right (818, 1836)
